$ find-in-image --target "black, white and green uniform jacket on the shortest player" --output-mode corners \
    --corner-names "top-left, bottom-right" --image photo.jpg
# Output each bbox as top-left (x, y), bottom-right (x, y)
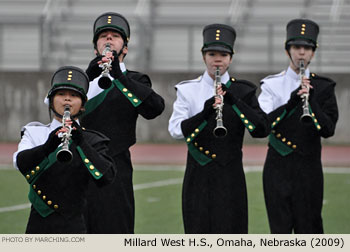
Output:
top-left (14, 119), bottom-right (116, 219)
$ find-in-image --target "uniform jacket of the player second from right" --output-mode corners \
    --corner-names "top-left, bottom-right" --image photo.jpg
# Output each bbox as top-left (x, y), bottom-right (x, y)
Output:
top-left (169, 72), bottom-right (269, 165)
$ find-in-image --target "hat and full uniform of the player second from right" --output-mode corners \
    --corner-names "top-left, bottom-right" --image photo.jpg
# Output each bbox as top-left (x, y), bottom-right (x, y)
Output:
top-left (169, 24), bottom-right (269, 233)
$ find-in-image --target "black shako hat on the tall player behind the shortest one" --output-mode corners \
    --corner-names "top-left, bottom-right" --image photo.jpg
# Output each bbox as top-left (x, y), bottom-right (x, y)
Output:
top-left (93, 12), bottom-right (130, 45)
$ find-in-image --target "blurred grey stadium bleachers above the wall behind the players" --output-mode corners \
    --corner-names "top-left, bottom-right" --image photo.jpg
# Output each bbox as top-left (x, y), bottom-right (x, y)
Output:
top-left (0, 0), bottom-right (350, 73)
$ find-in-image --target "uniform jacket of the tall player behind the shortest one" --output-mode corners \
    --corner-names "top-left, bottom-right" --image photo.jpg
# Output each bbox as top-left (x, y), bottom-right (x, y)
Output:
top-left (82, 63), bottom-right (164, 156)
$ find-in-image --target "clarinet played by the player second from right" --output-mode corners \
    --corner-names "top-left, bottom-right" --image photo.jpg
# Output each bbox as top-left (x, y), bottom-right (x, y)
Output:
top-left (213, 67), bottom-right (227, 137)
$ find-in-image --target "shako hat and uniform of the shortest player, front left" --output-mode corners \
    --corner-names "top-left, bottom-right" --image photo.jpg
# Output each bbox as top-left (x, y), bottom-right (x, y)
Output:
top-left (14, 67), bottom-right (116, 233)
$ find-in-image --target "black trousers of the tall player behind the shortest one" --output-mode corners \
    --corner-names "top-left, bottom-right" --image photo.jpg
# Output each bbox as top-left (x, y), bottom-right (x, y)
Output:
top-left (86, 150), bottom-right (135, 234)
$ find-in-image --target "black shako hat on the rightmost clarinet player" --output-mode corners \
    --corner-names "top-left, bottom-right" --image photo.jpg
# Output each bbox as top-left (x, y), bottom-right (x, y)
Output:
top-left (285, 19), bottom-right (319, 50)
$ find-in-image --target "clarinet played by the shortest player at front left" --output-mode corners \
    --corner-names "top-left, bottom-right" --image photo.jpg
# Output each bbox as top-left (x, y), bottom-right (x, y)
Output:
top-left (56, 105), bottom-right (73, 164)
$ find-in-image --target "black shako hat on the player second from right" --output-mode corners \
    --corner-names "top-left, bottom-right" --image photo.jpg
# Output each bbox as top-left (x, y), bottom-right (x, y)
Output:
top-left (202, 24), bottom-right (236, 54)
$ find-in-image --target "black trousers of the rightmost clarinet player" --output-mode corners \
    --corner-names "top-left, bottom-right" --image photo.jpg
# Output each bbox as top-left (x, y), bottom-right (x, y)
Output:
top-left (263, 148), bottom-right (323, 234)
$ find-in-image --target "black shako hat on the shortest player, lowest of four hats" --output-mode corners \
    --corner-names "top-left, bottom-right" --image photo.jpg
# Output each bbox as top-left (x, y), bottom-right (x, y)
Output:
top-left (47, 66), bottom-right (89, 104)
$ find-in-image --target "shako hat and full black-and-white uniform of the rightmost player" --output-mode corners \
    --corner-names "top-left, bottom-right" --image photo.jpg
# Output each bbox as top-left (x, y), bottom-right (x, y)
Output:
top-left (259, 19), bottom-right (338, 233)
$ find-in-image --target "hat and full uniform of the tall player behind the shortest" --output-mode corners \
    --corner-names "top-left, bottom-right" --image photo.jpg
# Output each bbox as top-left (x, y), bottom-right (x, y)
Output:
top-left (82, 12), bottom-right (164, 233)
